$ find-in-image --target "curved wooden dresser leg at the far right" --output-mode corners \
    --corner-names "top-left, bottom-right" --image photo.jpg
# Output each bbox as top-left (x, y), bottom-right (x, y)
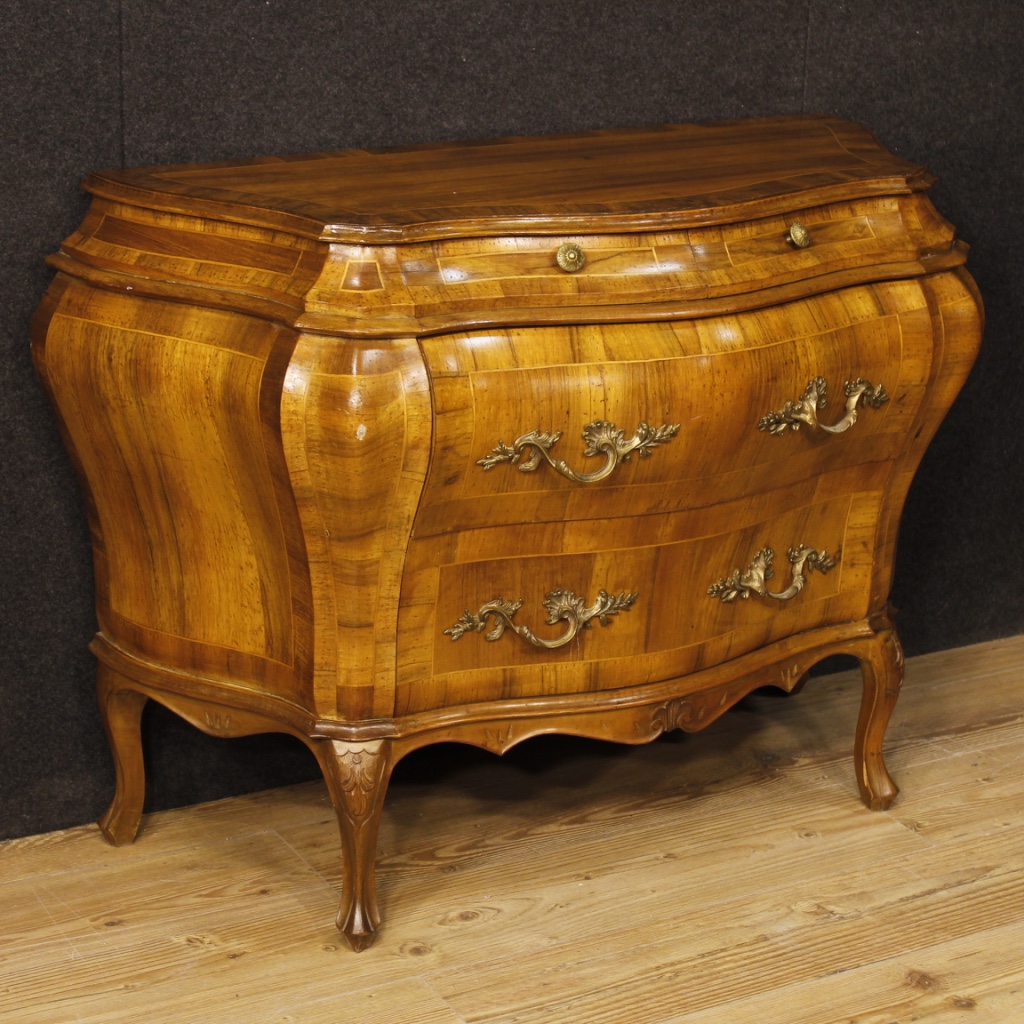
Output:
top-left (853, 629), bottom-right (903, 811)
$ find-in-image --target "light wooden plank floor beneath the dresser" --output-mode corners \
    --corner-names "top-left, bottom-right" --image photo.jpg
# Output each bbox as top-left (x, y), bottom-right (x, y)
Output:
top-left (0, 637), bottom-right (1024, 1024)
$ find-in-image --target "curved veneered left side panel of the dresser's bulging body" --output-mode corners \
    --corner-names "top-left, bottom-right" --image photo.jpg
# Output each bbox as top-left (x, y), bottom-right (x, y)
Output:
top-left (37, 279), bottom-right (311, 705)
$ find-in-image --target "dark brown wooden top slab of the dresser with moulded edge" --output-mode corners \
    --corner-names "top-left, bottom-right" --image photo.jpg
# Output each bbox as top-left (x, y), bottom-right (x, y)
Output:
top-left (86, 115), bottom-right (932, 243)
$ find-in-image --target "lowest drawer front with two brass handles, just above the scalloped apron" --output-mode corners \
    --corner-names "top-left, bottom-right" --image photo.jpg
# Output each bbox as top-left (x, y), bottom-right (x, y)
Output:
top-left (396, 485), bottom-right (876, 715)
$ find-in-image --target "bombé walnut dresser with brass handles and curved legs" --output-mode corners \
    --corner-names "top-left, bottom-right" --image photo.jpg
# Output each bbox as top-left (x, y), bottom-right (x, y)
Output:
top-left (34, 117), bottom-right (982, 949)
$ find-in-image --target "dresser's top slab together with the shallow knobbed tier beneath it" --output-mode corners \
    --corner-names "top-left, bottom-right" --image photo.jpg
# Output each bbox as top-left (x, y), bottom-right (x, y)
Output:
top-left (61, 116), bottom-right (966, 337)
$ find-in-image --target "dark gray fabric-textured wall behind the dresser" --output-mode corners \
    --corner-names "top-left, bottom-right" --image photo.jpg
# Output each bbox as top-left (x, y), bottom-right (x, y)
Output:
top-left (0, 0), bottom-right (1024, 837)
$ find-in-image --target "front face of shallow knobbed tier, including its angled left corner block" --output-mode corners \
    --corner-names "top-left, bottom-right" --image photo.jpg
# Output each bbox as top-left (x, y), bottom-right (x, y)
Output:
top-left (300, 194), bottom-right (964, 334)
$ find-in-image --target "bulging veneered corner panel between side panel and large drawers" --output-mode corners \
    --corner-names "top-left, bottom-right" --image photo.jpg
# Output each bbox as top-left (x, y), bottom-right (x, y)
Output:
top-left (281, 335), bottom-right (431, 721)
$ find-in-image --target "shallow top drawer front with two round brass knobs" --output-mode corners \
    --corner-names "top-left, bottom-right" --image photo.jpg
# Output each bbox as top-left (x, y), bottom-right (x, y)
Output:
top-left (402, 195), bottom-right (937, 299)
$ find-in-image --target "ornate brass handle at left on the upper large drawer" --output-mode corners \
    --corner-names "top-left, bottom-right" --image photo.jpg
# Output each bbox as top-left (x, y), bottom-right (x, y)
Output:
top-left (476, 420), bottom-right (679, 483)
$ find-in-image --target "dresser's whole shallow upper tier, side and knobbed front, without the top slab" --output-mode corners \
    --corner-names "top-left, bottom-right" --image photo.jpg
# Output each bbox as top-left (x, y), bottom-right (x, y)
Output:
top-left (50, 186), bottom-right (966, 337)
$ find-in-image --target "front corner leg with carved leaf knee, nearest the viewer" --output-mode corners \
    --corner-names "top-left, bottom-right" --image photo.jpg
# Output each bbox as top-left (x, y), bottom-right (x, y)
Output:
top-left (312, 739), bottom-right (393, 952)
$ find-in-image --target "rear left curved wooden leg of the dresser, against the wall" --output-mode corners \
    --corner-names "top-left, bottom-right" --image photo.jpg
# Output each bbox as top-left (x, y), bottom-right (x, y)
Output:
top-left (96, 664), bottom-right (147, 846)
